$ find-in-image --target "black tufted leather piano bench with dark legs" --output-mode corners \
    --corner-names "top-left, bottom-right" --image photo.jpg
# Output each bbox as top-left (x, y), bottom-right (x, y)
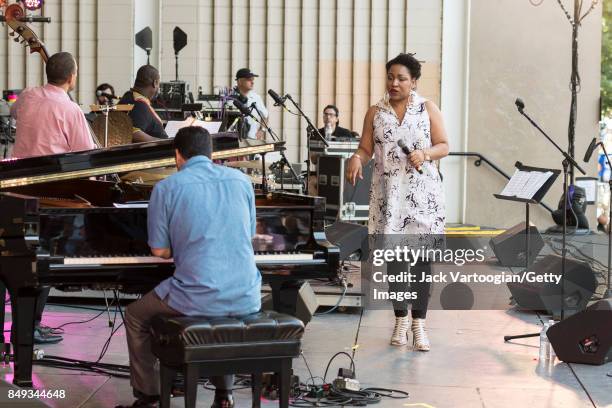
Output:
top-left (151, 311), bottom-right (304, 408)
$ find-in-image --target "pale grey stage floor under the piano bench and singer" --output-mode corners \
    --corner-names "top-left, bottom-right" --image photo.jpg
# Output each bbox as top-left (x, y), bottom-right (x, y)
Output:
top-left (0, 305), bottom-right (612, 408)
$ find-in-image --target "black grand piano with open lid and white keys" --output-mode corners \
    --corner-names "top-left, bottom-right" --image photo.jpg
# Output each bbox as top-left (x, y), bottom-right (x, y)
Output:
top-left (0, 140), bottom-right (339, 386)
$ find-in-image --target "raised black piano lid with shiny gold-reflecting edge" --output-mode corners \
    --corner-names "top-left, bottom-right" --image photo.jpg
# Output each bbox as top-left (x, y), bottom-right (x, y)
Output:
top-left (0, 139), bottom-right (284, 190)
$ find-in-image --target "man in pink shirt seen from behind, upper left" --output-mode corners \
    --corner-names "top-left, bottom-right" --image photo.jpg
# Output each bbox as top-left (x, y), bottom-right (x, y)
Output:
top-left (11, 52), bottom-right (95, 159)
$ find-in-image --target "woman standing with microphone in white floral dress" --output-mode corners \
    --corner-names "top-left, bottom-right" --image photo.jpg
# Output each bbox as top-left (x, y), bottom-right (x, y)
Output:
top-left (347, 54), bottom-right (448, 351)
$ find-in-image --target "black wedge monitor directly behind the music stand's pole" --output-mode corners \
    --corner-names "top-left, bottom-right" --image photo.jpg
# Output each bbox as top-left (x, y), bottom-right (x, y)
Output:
top-left (489, 222), bottom-right (544, 266)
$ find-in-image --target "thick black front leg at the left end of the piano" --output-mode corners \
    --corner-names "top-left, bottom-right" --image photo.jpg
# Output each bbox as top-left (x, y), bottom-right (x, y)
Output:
top-left (11, 288), bottom-right (39, 387)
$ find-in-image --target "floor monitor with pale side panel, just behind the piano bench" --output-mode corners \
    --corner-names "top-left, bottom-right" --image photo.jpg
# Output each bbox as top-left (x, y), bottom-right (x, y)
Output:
top-left (261, 281), bottom-right (319, 325)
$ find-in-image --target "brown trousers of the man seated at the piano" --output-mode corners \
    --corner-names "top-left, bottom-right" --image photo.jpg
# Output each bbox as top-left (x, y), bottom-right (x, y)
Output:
top-left (125, 291), bottom-right (234, 398)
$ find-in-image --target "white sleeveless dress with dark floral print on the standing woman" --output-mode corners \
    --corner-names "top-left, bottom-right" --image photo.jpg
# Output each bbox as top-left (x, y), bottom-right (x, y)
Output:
top-left (369, 92), bottom-right (445, 242)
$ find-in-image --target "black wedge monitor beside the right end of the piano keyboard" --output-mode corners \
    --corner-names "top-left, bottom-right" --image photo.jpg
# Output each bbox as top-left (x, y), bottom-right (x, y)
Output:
top-left (325, 221), bottom-right (368, 261)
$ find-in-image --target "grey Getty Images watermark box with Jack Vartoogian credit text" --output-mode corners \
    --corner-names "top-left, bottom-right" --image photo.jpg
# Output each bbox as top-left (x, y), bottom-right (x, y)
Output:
top-left (361, 235), bottom-right (592, 310)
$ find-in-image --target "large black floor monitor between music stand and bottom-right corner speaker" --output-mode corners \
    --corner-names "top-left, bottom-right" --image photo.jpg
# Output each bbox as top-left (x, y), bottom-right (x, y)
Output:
top-left (507, 255), bottom-right (597, 315)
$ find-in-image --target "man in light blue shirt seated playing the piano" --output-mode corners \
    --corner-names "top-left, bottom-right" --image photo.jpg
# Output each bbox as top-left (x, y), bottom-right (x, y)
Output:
top-left (118, 127), bottom-right (261, 408)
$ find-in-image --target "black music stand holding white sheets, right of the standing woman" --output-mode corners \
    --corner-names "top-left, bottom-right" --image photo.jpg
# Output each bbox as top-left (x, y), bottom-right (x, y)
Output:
top-left (493, 162), bottom-right (565, 341)
